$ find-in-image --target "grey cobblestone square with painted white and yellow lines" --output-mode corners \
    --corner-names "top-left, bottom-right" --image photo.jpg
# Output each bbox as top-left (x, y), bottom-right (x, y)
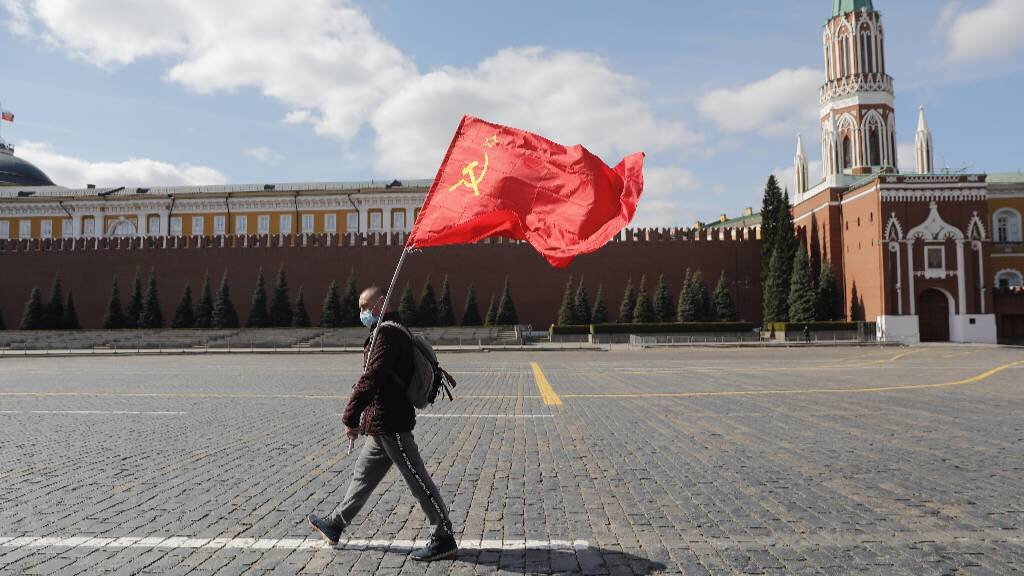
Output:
top-left (0, 346), bottom-right (1024, 576)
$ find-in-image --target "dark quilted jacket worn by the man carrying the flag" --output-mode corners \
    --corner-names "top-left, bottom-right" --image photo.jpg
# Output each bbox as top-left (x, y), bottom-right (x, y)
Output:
top-left (342, 313), bottom-right (416, 436)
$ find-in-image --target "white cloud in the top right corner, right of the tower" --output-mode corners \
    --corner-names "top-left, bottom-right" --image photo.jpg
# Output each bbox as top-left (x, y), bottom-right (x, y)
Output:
top-left (943, 0), bottom-right (1024, 63)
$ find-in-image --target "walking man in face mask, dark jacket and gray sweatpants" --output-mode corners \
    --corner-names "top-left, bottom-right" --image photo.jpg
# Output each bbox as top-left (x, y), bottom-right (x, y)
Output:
top-left (309, 286), bottom-right (459, 561)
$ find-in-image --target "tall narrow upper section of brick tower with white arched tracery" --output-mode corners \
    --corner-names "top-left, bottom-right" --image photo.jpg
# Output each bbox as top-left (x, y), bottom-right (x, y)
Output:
top-left (820, 0), bottom-right (896, 178)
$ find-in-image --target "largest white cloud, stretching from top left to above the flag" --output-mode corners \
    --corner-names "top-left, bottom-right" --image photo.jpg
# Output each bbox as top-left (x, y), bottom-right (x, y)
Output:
top-left (0, 0), bottom-right (700, 177)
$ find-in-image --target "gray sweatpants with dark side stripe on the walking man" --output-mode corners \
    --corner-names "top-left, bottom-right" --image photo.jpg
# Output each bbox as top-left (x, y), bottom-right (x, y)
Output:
top-left (332, 433), bottom-right (455, 537)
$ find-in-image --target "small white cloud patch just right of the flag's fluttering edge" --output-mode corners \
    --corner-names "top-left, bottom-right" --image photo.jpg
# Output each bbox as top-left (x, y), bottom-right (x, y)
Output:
top-left (630, 166), bottom-right (705, 228)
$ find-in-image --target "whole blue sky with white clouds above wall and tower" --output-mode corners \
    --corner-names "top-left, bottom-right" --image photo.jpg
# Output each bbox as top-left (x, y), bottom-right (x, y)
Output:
top-left (0, 0), bottom-right (1024, 225)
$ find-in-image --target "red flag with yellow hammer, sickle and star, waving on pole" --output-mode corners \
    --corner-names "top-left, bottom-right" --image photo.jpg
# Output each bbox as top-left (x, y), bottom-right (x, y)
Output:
top-left (408, 116), bottom-right (643, 268)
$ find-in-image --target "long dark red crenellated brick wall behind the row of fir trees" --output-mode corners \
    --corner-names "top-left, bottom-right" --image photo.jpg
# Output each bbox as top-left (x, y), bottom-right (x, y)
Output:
top-left (0, 229), bottom-right (761, 328)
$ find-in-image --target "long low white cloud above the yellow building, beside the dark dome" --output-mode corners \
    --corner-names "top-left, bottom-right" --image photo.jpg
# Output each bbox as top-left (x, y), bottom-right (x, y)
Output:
top-left (17, 141), bottom-right (227, 188)
